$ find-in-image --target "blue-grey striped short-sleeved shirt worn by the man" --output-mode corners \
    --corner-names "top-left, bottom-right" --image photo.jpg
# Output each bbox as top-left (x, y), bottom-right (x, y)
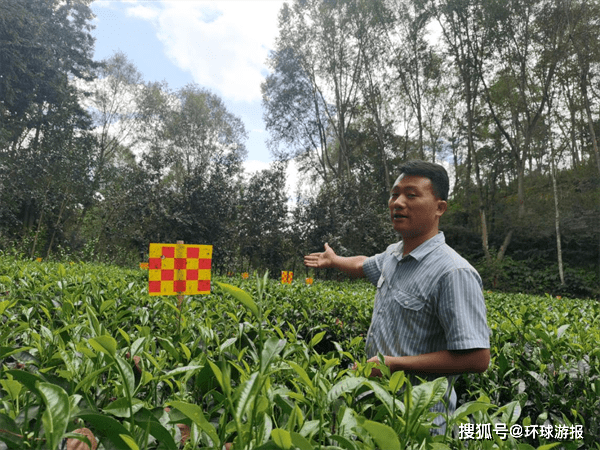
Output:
top-left (363, 232), bottom-right (490, 422)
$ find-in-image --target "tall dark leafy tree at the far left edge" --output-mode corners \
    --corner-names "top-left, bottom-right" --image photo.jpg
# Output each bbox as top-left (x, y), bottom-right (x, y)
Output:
top-left (0, 0), bottom-right (95, 254)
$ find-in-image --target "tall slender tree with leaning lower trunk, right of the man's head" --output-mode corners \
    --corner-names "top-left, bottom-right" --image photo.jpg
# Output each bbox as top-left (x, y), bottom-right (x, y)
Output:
top-left (474, 0), bottom-right (573, 260)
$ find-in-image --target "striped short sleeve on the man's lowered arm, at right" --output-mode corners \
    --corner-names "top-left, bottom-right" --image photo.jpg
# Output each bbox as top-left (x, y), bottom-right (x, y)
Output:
top-left (437, 268), bottom-right (490, 350)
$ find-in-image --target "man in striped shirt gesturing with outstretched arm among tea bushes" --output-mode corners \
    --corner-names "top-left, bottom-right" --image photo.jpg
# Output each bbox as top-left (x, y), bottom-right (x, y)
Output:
top-left (304, 161), bottom-right (490, 424)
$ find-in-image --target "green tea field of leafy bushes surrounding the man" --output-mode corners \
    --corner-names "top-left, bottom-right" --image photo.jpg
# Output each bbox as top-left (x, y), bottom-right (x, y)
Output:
top-left (0, 256), bottom-right (600, 450)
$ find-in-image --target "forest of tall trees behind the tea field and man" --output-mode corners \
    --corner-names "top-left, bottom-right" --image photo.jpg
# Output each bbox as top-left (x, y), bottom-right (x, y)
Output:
top-left (0, 0), bottom-right (600, 298)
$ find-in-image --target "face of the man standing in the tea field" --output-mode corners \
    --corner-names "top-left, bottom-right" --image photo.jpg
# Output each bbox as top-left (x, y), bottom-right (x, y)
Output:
top-left (388, 174), bottom-right (447, 239)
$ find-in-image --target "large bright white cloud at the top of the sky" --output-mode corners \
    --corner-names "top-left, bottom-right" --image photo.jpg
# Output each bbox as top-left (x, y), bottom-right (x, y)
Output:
top-left (128, 0), bottom-right (283, 102)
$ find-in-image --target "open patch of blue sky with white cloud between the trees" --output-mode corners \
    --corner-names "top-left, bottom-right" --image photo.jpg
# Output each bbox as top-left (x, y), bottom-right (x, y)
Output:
top-left (91, 0), bottom-right (293, 178)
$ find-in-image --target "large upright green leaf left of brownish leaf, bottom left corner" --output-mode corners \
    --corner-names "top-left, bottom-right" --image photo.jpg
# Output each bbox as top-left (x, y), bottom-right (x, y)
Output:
top-left (37, 383), bottom-right (71, 449)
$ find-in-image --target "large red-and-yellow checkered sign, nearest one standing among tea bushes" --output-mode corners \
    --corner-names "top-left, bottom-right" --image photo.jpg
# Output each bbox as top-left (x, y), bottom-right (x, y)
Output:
top-left (148, 244), bottom-right (212, 295)
